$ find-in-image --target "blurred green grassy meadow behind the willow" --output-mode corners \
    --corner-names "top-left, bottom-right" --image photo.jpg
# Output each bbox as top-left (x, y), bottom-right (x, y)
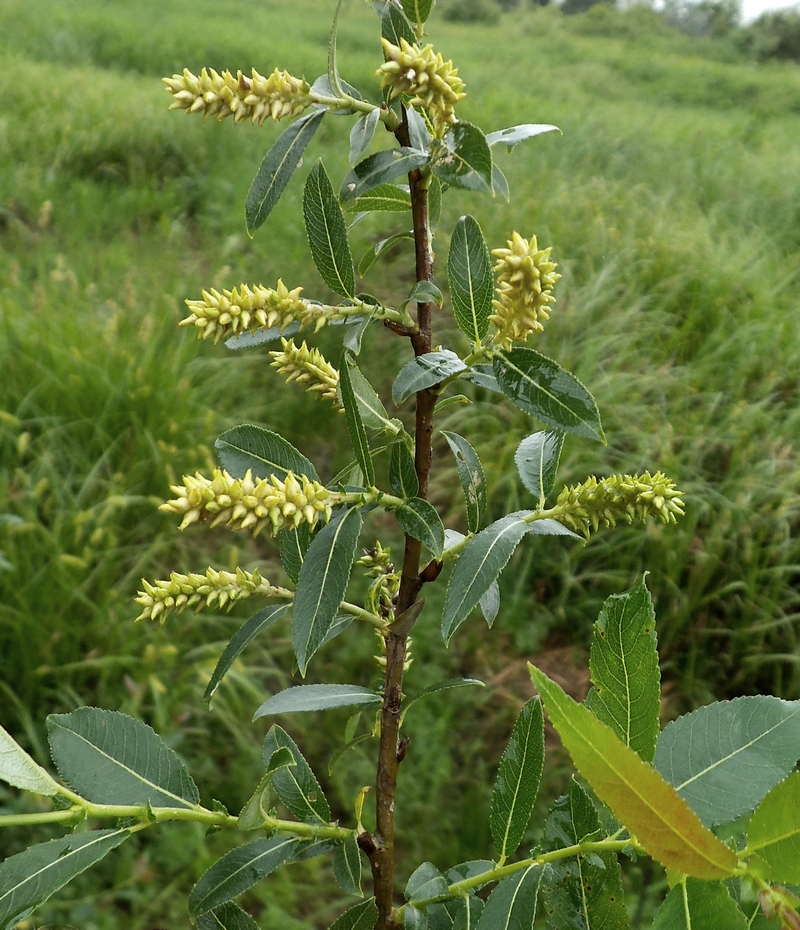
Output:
top-left (0, 0), bottom-right (800, 930)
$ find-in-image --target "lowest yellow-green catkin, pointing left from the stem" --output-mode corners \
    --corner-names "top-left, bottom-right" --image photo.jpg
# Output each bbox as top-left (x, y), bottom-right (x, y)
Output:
top-left (135, 568), bottom-right (290, 623)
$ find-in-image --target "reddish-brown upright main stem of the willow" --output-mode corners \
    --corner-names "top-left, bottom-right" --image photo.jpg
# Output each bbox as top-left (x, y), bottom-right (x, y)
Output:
top-left (370, 115), bottom-right (436, 930)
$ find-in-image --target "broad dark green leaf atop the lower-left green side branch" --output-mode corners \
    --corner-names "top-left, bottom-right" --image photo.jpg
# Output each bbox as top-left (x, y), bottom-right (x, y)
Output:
top-left (47, 707), bottom-right (200, 807)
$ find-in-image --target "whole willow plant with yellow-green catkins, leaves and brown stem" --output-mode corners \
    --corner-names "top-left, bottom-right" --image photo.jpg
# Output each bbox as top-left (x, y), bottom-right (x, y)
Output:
top-left (0, 0), bottom-right (800, 930)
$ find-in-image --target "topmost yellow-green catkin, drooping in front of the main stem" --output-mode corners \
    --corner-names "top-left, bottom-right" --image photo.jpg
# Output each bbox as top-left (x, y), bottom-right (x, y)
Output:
top-left (375, 39), bottom-right (466, 136)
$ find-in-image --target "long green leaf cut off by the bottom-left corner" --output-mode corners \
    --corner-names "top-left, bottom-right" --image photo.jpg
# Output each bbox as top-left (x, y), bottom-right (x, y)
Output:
top-left (0, 830), bottom-right (130, 930)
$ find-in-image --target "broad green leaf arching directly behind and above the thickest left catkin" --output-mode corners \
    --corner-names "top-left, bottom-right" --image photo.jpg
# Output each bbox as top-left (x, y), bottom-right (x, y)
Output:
top-left (214, 423), bottom-right (319, 481)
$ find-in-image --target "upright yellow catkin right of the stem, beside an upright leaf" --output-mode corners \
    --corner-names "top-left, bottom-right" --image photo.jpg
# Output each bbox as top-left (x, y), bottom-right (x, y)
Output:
top-left (489, 231), bottom-right (561, 349)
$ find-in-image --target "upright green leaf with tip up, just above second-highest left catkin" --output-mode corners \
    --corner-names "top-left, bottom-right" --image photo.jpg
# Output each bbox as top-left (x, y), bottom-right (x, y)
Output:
top-left (303, 159), bottom-right (356, 297)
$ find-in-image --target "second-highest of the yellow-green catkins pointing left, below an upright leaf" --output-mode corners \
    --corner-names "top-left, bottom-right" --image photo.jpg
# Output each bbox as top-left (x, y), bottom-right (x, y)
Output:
top-left (179, 280), bottom-right (318, 342)
